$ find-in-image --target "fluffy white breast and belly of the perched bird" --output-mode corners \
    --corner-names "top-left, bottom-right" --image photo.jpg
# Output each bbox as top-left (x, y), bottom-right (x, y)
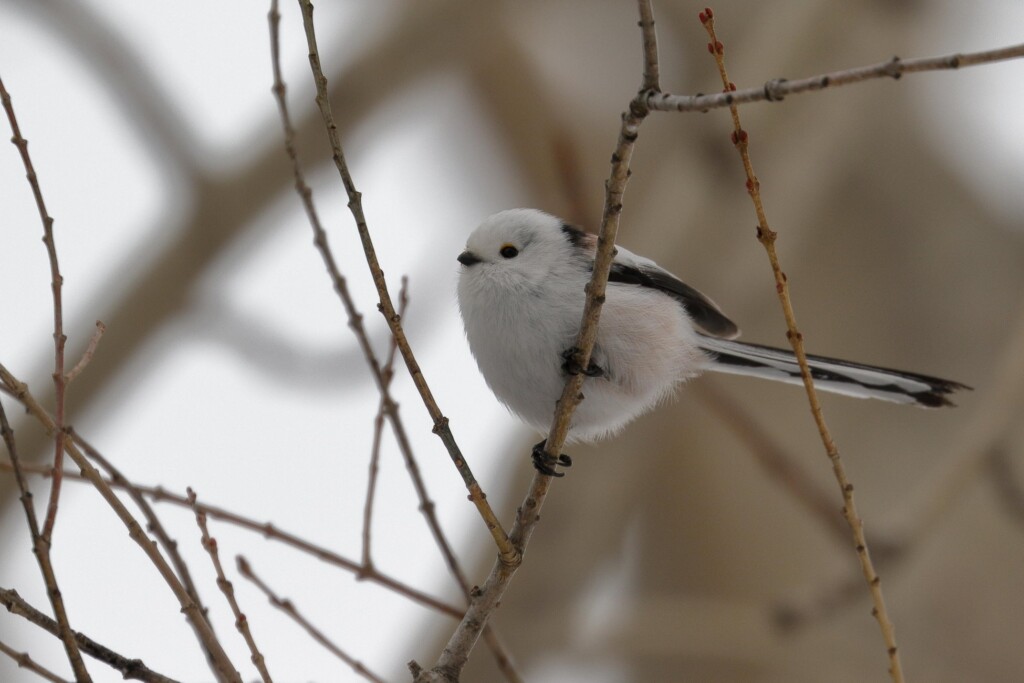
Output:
top-left (466, 287), bottom-right (703, 441)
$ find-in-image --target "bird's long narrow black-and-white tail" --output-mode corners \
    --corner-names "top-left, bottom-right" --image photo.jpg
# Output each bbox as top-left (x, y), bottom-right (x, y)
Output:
top-left (700, 336), bottom-right (971, 408)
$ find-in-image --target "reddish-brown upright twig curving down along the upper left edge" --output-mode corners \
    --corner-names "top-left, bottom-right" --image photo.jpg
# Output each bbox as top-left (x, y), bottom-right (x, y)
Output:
top-left (0, 74), bottom-right (67, 544)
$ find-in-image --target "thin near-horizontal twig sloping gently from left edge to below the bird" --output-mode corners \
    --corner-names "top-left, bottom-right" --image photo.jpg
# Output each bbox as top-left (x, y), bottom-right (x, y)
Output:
top-left (0, 460), bottom-right (465, 618)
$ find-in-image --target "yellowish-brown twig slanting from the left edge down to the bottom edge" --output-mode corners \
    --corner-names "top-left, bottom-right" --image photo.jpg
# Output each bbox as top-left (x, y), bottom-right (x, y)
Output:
top-left (0, 364), bottom-right (242, 683)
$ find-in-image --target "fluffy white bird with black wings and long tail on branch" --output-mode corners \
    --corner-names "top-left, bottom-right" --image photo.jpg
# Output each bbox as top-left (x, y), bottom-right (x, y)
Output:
top-left (458, 209), bottom-right (970, 474)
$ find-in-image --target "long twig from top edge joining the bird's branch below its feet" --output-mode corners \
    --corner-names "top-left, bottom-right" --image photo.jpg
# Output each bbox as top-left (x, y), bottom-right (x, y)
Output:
top-left (299, 0), bottom-right (519, 564)
